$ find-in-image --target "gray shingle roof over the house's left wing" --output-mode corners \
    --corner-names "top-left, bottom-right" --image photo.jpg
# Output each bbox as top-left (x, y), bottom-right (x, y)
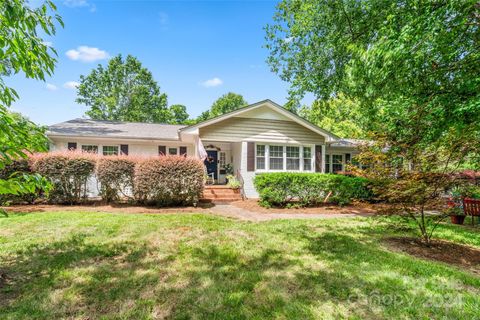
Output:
top-left (47, 119), bottom-right (185, 140)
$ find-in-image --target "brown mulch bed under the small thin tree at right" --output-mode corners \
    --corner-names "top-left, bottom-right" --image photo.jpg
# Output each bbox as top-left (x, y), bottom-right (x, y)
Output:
top-left (385, 237), bottom-right (480, 274)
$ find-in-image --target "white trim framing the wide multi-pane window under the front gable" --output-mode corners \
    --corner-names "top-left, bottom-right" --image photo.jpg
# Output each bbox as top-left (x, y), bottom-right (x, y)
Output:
top-left (255, 142), bottom-right (315, 173)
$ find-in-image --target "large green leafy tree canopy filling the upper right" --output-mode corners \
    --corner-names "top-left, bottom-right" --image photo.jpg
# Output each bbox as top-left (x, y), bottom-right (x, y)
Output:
top-left (266, 0), bottom-right (480, 241)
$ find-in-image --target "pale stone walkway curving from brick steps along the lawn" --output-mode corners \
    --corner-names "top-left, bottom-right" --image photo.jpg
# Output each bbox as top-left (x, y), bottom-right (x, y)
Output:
top-left (210, 204), bottom-right (368, 221)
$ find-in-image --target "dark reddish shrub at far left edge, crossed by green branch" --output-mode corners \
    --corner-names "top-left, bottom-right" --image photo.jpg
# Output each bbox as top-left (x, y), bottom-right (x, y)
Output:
top-left (0, 159), bottom-right (37, 204)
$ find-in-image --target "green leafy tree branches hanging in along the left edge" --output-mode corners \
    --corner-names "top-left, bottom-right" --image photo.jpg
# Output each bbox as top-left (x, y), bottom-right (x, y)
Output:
top-left (0, 0), bottom-right (63, 200)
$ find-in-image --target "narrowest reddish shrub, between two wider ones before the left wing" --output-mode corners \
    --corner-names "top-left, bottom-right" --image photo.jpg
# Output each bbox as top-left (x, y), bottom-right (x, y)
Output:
top-left (96, 156), bottom-right (137, 202)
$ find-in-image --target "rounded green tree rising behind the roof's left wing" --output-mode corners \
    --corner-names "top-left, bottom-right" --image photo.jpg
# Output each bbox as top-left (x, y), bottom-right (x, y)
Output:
top-left (76, 55), bottom-right (171, 123)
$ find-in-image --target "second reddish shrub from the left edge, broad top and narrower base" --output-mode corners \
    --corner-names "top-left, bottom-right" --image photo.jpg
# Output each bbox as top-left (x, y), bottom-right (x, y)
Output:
top-left (31, 151), bottom-right (97, 204)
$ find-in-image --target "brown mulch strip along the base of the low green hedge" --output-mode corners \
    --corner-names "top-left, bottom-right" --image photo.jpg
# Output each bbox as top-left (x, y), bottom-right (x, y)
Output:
top-left (232, 199), bottom-right (379, 215)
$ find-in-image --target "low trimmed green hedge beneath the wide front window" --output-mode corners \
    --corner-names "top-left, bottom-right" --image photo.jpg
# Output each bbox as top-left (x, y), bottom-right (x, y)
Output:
top-left (254, 172), bottom-right (372, 207)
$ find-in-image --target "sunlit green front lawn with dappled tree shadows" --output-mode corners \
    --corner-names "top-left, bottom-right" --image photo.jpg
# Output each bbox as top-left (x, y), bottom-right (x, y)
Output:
top-left (0, 212), bottom-right (480, 319)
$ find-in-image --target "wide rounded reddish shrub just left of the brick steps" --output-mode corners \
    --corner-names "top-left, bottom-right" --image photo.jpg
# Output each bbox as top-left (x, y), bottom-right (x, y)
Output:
top-left (134, 156), bottom-right (204, 206)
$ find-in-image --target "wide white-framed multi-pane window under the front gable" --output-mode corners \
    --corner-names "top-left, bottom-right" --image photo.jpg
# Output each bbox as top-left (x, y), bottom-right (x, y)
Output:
top-left (255, 144), bottom-right (314, 171)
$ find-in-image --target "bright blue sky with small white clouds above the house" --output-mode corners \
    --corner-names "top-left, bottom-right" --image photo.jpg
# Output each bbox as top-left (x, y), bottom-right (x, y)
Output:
top-left (8, 0), bottom-right (312, 125)
